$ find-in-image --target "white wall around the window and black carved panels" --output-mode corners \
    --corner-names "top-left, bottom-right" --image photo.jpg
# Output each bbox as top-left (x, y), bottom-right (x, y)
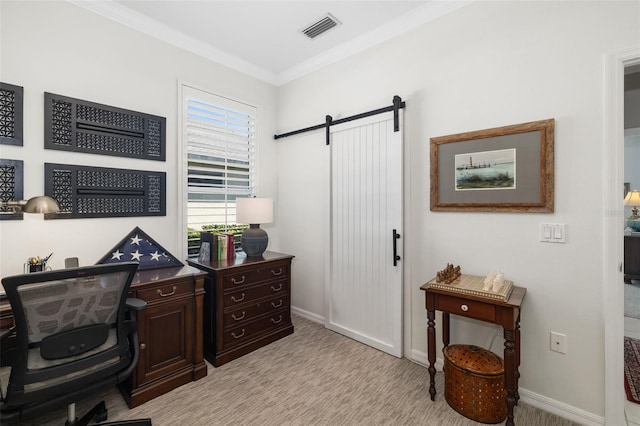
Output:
top-left (0, 1), bottom-right (277, 276)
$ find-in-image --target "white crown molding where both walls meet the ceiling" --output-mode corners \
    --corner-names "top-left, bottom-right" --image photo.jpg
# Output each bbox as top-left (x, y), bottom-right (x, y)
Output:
top-left (67, 0), bottom-right (476, 86)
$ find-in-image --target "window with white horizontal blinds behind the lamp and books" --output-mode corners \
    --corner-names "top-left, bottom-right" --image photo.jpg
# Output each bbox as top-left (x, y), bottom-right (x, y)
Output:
top-left (182, 86), bottom-right (256, 256)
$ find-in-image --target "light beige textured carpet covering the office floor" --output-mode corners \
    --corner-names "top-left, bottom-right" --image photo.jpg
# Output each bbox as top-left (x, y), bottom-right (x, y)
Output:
top-left (8, 316), bottom-right (574, 426)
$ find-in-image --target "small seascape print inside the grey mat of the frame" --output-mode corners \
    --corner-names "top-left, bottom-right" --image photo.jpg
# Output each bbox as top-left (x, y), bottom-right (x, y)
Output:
top-left (454, 148), bottom-right (516, 191)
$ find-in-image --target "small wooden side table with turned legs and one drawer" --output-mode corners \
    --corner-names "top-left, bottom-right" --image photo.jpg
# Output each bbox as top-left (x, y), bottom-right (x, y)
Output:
top-left (420, 283), bottom-right (527, 425)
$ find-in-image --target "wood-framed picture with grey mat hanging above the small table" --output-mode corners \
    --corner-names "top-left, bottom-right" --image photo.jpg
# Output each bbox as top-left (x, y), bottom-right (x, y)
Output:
top-left (430, 119), bottom-right (555, 213)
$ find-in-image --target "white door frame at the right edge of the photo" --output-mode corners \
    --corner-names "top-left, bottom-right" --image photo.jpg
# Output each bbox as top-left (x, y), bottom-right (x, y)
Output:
top-left (602, 47), bottom-right (640, 424)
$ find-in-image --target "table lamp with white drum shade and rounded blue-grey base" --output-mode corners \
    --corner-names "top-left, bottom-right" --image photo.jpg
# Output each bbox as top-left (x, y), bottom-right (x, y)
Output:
top-left (236, 198), bottom-right (273, 257)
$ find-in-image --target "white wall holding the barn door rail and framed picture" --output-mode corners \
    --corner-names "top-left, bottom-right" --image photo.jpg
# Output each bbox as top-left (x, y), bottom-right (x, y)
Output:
top-left (278, 1), bottom-right (640, 421)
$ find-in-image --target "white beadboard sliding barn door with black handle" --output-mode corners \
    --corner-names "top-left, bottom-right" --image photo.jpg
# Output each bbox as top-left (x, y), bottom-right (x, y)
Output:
top-left (325, 113), bottom-right (403, 357)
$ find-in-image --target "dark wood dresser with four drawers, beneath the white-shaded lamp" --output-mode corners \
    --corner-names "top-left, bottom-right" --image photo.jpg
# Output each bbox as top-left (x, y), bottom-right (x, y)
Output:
top-left (188, 251), bottom-right (293, 367)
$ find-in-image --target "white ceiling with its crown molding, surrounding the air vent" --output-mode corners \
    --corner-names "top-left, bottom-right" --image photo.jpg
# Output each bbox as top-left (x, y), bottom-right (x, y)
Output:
top-left (68, 0), bottom-right (473, 85)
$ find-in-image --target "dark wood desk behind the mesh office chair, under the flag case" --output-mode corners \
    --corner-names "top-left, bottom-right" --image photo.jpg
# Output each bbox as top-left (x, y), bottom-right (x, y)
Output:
top-left (0, 266), bottom-right (207, 408)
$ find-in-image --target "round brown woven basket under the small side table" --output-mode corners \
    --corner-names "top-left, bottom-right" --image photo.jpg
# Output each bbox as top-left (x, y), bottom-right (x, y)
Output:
top-left (444, 345), bottom-right (507, 423)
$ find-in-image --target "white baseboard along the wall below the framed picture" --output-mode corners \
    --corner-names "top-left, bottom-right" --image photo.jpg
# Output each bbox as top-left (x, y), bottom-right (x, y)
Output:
top-left (410, 349), bottom-right (604, 426)
